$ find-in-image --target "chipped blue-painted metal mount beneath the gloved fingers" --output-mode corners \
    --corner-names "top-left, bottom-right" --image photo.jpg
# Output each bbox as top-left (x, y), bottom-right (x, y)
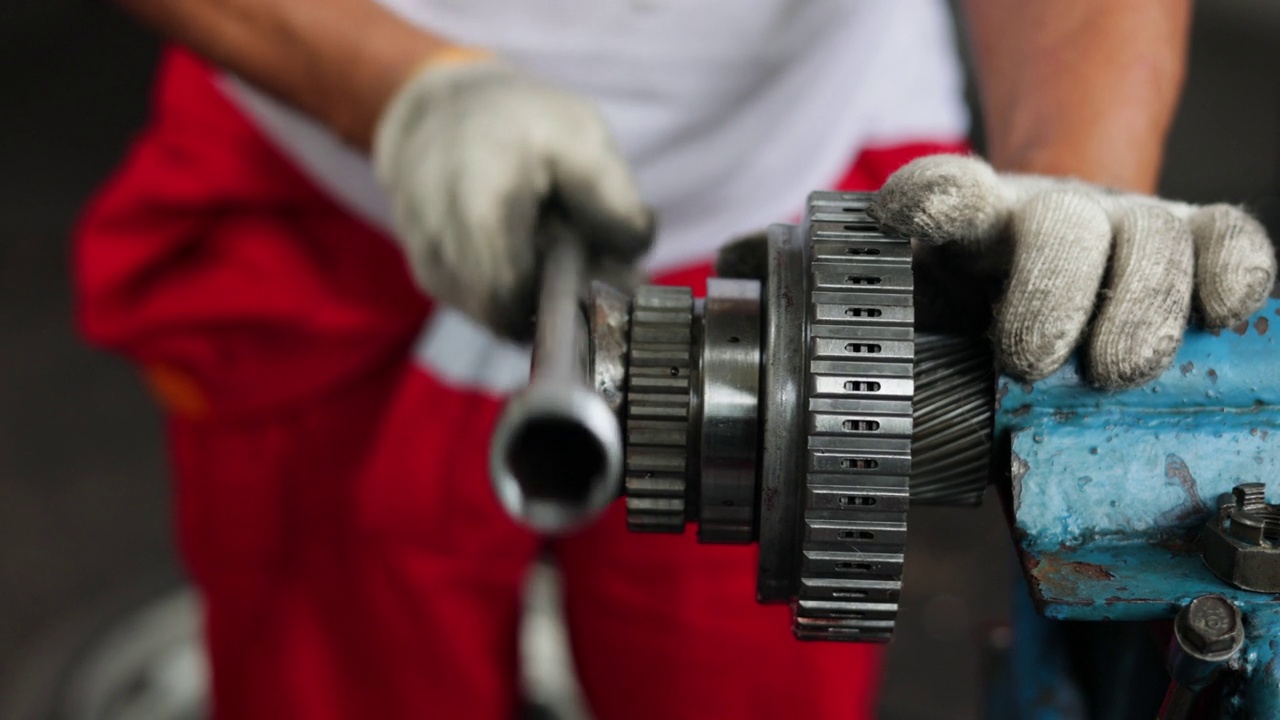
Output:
top-left (996, 300), bottom-right (1280, 719)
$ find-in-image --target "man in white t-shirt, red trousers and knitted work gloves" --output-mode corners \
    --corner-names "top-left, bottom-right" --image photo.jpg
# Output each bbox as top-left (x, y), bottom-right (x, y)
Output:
top-left (77, 0), bottom-right (1274, 719)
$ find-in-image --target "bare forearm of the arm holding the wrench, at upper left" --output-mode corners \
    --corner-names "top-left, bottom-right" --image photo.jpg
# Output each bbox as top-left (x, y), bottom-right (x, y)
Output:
top-left (116, 0), bottom-right (473, 149)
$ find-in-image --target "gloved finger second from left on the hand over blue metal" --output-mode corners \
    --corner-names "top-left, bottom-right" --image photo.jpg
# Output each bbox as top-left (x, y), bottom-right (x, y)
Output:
top-left (996, 188), bottom-right (1111, 379)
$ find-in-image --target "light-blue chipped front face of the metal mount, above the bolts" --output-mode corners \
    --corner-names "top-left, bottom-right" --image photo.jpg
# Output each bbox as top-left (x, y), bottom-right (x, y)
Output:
top-left (1011, 409), bottom-right (1280, 546)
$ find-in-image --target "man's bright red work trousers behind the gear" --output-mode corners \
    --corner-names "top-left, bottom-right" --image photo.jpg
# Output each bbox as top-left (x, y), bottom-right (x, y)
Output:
top-left (76, 51), bottom-right (957, 720)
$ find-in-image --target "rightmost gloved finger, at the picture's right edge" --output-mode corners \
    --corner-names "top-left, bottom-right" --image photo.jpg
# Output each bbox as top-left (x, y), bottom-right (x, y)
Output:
top-left (1190, 205), bottom-right (1276, 328)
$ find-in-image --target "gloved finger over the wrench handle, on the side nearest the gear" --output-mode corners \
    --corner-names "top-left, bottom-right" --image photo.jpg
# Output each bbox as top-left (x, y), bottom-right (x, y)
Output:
top-left (548, 102), bottom-right (654, 261)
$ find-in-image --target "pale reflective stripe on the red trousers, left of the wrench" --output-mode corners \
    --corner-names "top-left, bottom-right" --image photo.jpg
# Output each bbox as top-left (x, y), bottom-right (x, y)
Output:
top-left (413, 307), bottom-right (530, 395)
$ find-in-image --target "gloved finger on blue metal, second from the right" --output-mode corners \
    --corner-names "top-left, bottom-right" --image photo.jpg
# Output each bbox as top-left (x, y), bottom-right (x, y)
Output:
top-left (1088, 204), bottom-right (1194, 388)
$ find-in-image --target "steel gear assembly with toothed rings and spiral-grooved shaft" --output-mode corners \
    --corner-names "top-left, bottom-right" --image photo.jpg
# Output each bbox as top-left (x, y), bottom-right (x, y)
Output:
top-left (606, 192), bottom-right (977, 642)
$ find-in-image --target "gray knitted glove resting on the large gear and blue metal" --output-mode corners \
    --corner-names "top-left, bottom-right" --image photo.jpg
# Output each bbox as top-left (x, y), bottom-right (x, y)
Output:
top-left (870, 155), bottom-right (1276, 387)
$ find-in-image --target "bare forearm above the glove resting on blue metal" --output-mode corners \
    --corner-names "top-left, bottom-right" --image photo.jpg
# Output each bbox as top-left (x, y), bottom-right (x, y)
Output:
top-left (965, 0), bottom-right (1190, 192)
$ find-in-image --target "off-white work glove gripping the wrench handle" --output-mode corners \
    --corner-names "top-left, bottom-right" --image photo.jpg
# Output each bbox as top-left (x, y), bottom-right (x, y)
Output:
top-left (372, 53), bottom-right (653, 340)
